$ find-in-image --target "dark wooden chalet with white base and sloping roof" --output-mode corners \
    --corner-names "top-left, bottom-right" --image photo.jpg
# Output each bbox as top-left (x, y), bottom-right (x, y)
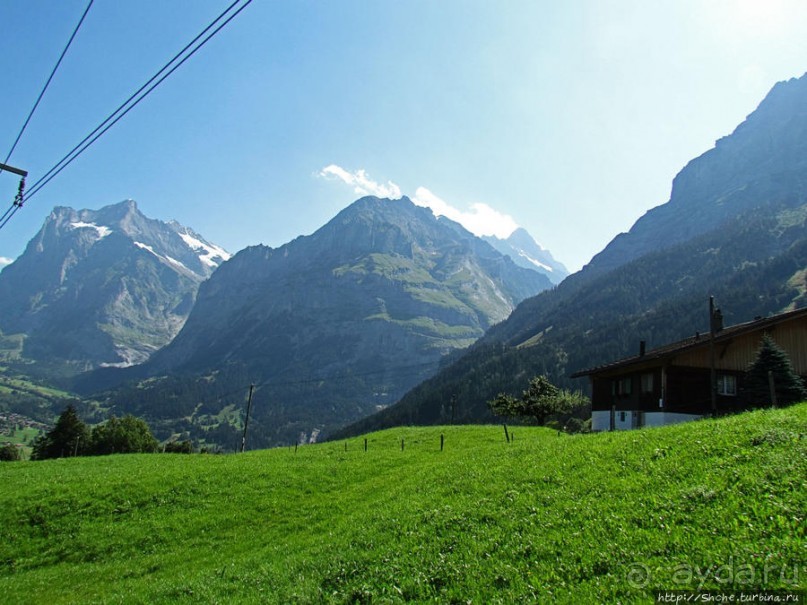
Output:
top-left (572, 309), bottom-right (807, 431)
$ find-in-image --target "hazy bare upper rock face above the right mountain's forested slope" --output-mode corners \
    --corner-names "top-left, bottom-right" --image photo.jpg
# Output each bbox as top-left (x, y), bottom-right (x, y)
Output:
top-left (587, 74), bottom-right (807, 274)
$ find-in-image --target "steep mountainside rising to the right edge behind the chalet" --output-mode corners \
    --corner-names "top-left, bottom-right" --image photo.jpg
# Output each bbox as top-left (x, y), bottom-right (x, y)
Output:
top-left (338, 74), bottom-right (807, 436)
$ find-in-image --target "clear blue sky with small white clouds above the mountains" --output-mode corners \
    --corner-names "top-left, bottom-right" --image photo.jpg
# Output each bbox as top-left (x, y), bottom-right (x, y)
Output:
top-left (0, 0), bottom-right (807, 271)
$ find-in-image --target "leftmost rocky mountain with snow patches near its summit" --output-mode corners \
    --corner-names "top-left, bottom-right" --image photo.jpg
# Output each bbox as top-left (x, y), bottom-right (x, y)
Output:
top-left (0, 200), bottom-right (229, 373)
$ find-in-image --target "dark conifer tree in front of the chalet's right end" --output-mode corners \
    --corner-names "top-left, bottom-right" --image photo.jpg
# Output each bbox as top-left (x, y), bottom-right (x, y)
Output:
top-left (743, 335), bottom-right (807, 404)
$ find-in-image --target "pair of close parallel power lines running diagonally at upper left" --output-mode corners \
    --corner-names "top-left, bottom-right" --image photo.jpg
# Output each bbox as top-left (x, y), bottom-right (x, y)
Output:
top-left (0, 0), bottom-right (252, 229)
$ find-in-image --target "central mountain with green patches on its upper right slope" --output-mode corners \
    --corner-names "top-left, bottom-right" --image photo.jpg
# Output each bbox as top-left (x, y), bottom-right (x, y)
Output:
top-left (79, 197), bottom-right (552, 446)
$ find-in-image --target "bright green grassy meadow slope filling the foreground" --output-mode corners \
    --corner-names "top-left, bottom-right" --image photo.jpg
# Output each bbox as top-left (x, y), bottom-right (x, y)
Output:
top-left (0, 404), bottom-right (807, 605)
